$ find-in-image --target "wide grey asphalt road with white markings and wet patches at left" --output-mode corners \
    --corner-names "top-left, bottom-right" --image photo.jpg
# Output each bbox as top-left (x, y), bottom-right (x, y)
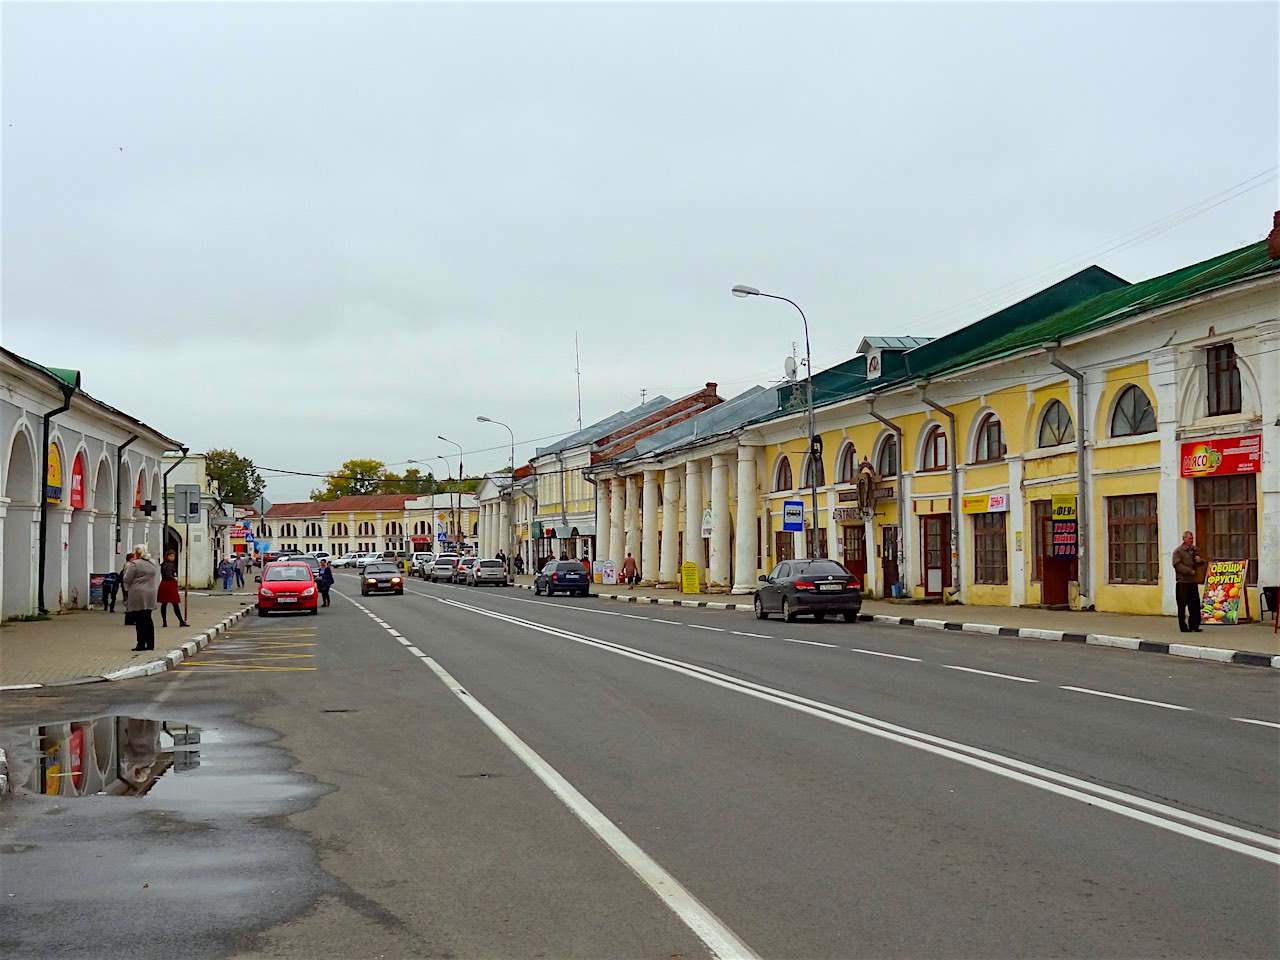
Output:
top-left (0, 575), bottom-right (1280, 960)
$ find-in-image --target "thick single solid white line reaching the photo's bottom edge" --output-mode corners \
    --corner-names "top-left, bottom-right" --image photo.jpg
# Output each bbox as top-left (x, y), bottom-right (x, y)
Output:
top-left (422, 657), bottom-right (756, 960)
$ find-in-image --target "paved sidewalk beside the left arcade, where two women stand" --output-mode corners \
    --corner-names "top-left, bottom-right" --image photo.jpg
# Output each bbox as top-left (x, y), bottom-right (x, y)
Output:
top-left (0, 580), bottom-right (256, 691)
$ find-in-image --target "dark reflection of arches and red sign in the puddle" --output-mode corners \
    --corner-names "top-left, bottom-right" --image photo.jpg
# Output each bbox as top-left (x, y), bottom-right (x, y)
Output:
top-left (8, 716), bottom-right (201, 796)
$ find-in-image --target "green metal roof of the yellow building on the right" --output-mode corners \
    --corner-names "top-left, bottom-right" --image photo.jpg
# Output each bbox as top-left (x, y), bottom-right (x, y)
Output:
top-left (754, 241), bottom-right (1280, 422)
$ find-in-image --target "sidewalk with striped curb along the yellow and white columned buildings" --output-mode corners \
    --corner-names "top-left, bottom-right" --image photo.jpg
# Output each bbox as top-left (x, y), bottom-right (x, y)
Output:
top-left (516, 576), bottom-right (1280, 668)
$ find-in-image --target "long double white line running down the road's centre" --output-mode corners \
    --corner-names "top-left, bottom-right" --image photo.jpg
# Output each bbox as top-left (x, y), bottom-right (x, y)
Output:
top-left (442, 599), bottom-right (1280, 865)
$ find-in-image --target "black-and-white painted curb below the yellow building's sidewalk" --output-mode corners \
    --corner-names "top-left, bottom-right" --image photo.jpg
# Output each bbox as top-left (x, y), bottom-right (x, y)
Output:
top-left (516, 584), bottom-right (1280, 669)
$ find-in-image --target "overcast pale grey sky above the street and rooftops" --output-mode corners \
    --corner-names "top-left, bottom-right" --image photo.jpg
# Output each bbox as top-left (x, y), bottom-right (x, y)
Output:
top-left (0, 3), bottom-right (1280, 502)
